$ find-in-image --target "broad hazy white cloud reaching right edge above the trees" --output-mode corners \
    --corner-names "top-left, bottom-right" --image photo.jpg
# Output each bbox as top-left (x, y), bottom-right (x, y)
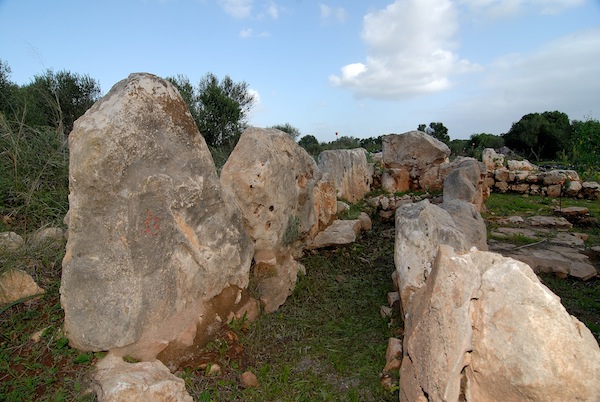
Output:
top-left (444, 28), bottom-right (600, 134)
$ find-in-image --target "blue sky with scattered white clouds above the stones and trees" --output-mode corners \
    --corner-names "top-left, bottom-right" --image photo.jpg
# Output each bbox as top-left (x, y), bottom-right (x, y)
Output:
top-left (0, 0), bottom-right (600, 142)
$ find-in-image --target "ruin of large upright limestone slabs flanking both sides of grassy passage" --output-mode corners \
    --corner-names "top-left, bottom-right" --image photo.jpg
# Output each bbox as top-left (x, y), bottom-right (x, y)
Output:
top-left (12, 73), bottom-right (600, 401)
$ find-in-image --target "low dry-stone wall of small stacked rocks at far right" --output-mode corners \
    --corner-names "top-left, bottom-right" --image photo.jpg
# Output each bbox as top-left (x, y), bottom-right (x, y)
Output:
top-left (482, 148), bottom-right (600, 200)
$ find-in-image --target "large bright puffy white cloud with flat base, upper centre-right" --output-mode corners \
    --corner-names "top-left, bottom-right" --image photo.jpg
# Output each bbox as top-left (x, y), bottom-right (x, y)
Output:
top-left (329, 0), bottom-right (481, 99)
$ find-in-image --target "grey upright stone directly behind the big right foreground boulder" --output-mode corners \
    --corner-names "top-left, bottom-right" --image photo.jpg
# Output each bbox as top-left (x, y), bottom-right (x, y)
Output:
top-left (394, 200), bottom-right (474, 311)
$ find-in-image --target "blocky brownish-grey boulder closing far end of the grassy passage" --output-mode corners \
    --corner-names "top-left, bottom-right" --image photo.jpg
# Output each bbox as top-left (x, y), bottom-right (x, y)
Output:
top-left (382, 131), bottom-right (450, 193)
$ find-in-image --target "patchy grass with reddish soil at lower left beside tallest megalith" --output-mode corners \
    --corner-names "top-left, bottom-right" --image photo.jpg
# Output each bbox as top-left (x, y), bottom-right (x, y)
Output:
top-left (0, 243), bottom-right (100, 401)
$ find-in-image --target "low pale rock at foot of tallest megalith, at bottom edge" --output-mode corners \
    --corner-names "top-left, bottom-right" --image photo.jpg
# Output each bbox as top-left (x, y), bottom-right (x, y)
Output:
top-left (93, 353), bottom-right (193, 402)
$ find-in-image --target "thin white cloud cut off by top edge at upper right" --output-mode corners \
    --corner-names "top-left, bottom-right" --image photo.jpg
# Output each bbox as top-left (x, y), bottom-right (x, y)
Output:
top-left (459, 0), bottom-right (585, 17)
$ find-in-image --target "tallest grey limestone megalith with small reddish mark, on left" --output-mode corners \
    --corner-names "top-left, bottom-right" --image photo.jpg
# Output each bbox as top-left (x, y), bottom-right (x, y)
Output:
top-left (61, 73), bottom-right (253, 359)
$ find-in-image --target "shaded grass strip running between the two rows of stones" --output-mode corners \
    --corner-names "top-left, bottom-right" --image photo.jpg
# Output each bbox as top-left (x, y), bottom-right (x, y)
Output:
top-left (180, 218), bottom-right (401, 401)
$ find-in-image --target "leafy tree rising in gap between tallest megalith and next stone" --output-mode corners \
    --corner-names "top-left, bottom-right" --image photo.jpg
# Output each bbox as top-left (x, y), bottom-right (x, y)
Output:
top-left (197, 73), bottom-right (254, 149)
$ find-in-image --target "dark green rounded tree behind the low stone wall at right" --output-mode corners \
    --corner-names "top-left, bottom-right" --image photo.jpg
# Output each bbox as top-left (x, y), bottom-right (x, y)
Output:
top-left (503, 111), bottom-right (571, 161)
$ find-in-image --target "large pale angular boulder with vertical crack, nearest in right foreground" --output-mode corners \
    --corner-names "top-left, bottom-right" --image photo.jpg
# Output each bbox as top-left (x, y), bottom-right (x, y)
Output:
top-left (400, 245), bottom-right (600, 401)
